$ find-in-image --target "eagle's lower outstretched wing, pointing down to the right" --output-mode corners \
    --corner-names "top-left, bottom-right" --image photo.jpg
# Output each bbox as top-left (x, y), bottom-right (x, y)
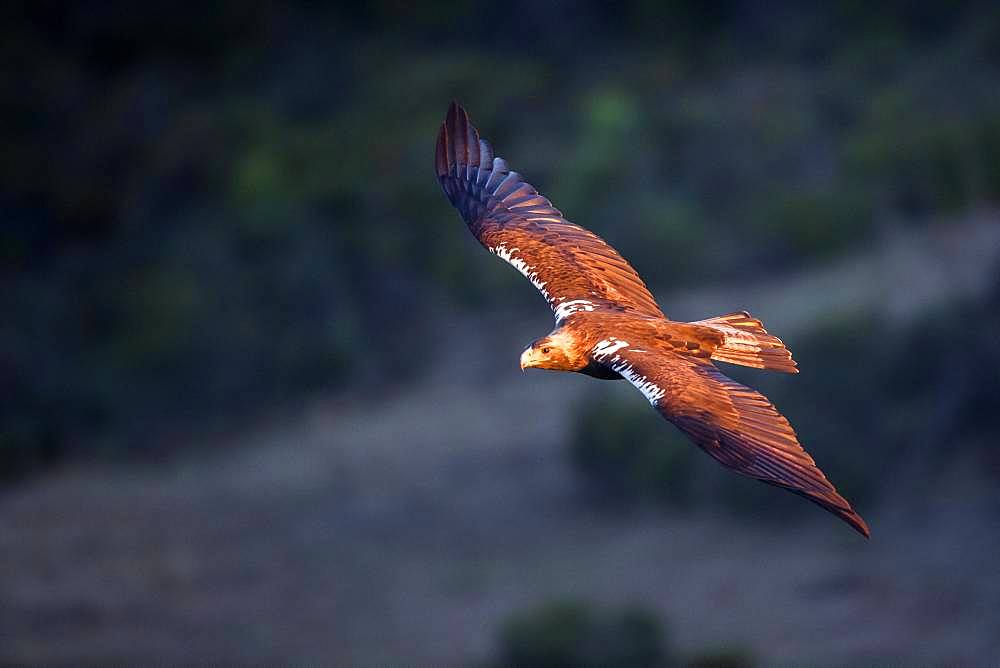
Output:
top-left (592, 337), bottom-right (869, 537)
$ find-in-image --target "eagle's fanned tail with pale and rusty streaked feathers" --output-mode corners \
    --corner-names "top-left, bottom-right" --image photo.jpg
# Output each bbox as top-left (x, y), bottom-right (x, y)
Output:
top-left (691, 311), bottom-right (799, 373)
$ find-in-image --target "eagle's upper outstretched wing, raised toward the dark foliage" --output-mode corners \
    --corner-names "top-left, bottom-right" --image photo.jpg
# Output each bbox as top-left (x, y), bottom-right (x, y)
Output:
top-left (435, 102), bottom-right (663, 321)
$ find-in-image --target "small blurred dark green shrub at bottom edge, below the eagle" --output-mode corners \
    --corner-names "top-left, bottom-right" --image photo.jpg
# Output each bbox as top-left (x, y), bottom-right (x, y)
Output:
top-left (497, 601), bottom-right (670, 668)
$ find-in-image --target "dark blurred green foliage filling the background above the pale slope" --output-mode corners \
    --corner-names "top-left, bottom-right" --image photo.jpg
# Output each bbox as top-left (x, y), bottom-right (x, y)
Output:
top-left (0, 0), bottom-right (1000, 474)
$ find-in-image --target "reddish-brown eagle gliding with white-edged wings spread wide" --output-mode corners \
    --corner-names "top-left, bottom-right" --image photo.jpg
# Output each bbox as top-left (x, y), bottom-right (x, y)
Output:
top-left (434, 102), bottom-right (870, 538)
